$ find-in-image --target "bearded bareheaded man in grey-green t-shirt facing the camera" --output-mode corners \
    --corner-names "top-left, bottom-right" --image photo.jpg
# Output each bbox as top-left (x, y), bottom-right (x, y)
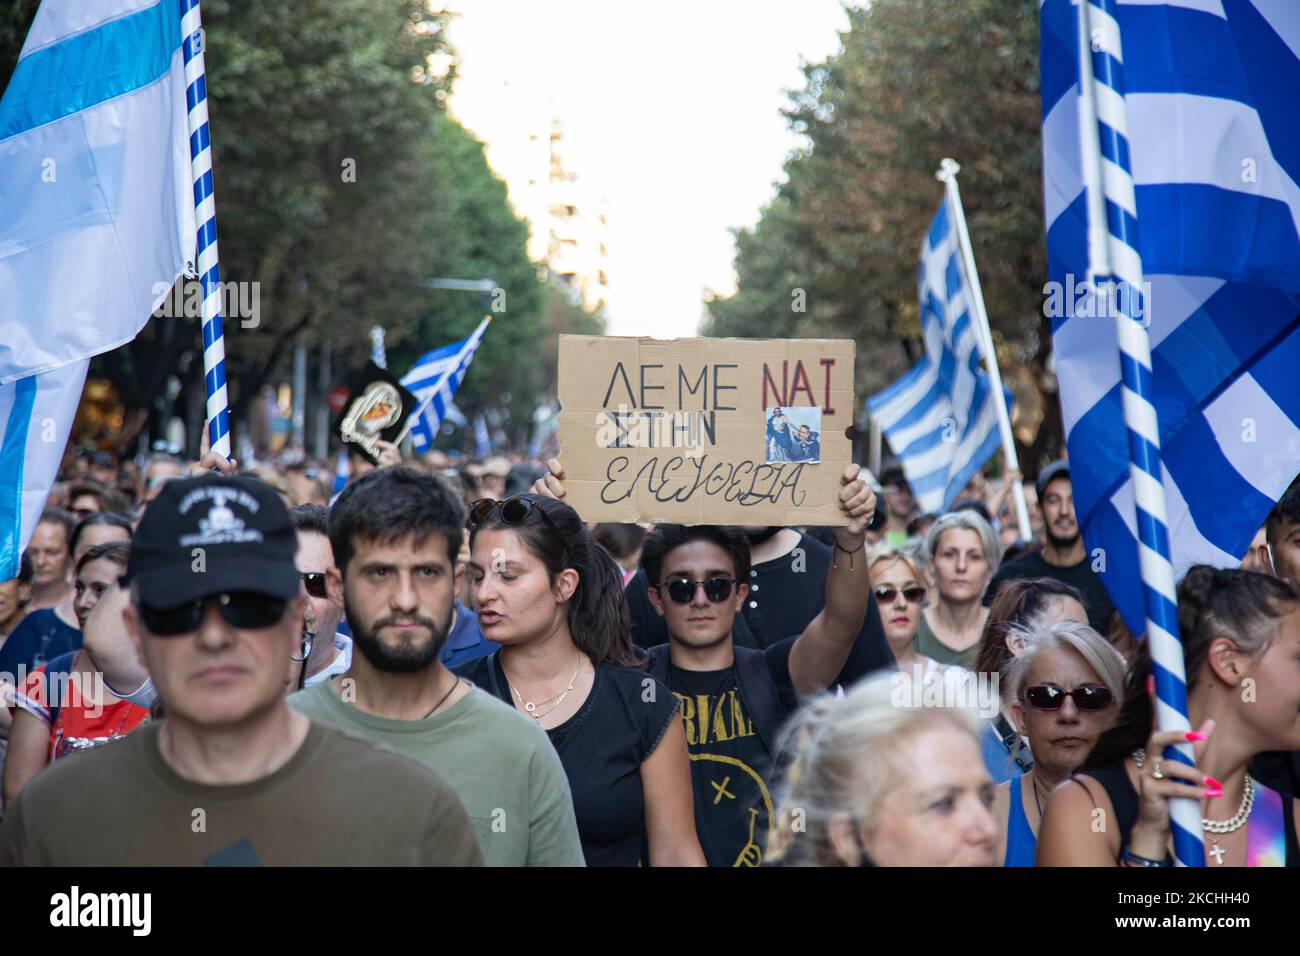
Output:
top-left (290, 466), bottom-right (582, 866)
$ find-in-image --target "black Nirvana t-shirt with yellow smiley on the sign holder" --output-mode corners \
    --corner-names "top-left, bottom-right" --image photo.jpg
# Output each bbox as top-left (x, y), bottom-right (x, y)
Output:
top-left (650, 635), bottom-right (798, 866)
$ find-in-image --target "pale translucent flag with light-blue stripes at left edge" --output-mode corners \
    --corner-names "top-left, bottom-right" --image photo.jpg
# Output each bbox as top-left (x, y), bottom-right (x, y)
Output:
top-left (0, 0), bottom-right (195, 580)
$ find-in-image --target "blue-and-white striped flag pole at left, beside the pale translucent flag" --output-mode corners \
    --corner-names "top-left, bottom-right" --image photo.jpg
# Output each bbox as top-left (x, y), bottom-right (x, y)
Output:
top-left (178, 0), bottom-right (230, 458)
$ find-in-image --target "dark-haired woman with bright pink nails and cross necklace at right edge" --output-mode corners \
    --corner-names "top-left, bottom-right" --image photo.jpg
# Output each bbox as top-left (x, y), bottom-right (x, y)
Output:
top-left (1037, 564), bottom-right (1300, 866)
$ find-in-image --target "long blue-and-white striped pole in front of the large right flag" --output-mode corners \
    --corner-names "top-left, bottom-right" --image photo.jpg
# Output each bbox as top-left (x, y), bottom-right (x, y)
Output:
top-left (1079, 0), bottom-right (1205, 866)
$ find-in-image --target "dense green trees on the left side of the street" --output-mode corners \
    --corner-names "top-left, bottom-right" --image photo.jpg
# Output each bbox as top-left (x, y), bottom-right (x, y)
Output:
top-left (0, 0), bottom-right (599, 455)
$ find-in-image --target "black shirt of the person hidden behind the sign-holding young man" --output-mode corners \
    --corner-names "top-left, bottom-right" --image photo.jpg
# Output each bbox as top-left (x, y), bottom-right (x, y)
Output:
top-left (623, 535), bottom-right (894, 684)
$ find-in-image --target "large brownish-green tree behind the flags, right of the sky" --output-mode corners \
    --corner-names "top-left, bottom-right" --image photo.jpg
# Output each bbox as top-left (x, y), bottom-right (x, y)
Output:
top-left (706, 0), bottom-right (1061, 463)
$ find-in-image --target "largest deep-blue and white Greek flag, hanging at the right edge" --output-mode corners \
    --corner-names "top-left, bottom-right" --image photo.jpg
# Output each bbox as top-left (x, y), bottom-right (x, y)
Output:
top-left (1040, 0), bottom-right (1300, 633)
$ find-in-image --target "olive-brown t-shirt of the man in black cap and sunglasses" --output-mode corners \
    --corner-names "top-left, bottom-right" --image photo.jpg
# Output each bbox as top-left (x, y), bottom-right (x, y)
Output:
top-left (0, 721), bottom-right (482, 866)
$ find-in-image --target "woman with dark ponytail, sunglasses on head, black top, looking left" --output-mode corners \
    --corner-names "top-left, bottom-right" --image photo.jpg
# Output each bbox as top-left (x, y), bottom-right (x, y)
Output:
top-left (455, 494), bottom-right (705, 866)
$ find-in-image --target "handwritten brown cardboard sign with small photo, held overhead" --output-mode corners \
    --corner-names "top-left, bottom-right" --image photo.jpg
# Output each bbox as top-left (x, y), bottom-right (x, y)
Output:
top-left (559, 336), bottom-right (854, 524)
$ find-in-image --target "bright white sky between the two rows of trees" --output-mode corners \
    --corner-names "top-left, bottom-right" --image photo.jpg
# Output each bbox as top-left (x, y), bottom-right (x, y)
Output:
top-left (451, 0), bottom-right (848, 338)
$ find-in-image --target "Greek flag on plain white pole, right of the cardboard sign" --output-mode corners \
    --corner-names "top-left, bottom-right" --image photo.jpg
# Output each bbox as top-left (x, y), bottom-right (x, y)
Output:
top-left (867, 199), bottom-right (1010, 511)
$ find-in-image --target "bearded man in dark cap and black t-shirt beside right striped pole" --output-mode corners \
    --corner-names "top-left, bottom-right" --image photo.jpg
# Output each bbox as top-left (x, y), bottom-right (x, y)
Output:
top-left (984, 460), bottom-right (1115, 635)
